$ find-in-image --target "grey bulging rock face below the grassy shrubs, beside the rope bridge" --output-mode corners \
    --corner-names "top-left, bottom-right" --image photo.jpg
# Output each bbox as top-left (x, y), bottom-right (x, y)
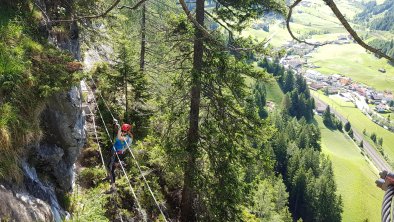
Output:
top-left (31, 87), bottom-right (86, 191)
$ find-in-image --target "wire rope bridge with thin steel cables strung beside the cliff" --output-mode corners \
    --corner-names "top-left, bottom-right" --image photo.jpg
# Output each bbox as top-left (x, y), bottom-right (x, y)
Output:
top-left (82, 78), bottom-right (168, 222)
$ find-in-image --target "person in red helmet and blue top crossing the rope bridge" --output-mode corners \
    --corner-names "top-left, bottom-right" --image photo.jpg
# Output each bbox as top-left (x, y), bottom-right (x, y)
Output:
top-left (108, 120), bottom-right (134, 193)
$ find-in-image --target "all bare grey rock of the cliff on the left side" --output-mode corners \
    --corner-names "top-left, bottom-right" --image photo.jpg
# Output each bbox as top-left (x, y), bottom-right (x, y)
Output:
top-left (0, 1), bottom-right (86, 221)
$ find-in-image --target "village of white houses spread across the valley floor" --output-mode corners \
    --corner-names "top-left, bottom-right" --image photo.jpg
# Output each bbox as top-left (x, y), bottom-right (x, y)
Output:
top-left (280, 35), bottom-right (394, 131)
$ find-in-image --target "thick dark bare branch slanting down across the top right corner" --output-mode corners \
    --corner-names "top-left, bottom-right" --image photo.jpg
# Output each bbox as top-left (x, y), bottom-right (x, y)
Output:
top-left (324, 0), bottom-right (394, 62)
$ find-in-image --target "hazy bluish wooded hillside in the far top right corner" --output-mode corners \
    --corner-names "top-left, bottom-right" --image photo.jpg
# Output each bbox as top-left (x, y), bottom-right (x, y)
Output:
top-left (355, 0), bottom-right (394, 31)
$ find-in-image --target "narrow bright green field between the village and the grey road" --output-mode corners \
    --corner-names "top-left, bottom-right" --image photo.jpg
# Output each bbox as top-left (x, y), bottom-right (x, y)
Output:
top-left (311, 91), bottom-right (394, 165)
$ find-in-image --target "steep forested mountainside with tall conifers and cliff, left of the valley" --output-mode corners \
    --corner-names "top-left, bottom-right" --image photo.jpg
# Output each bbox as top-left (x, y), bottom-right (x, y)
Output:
top-left (0, 0), bottom-right (392, 222)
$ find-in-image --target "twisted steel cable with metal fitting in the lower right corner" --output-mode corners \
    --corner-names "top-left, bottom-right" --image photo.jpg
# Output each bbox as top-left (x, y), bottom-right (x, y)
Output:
top-left (376, 170), bottom-right (394, 222)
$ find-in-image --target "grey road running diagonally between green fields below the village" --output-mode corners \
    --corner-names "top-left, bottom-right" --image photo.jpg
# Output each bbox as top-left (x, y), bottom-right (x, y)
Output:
top-left (312, 95), bottom-right (392, 172)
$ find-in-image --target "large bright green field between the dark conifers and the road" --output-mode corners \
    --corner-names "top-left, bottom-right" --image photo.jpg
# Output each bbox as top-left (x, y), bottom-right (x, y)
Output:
top-left (316, 116), bottom-right (384, 221)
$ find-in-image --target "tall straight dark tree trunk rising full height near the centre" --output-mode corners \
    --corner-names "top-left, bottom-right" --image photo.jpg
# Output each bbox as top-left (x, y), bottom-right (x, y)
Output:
top-left (180, 0), bottom-right (205, 222)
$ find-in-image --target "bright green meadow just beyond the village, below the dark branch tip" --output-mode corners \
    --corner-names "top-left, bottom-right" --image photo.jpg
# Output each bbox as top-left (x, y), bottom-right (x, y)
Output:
top-left (310, 44), bottom-right (394, 90)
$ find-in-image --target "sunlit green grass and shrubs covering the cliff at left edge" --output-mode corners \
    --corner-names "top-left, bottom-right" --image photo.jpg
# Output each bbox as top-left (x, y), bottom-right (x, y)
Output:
top-left (0, 16), bottom-right (77, 183)
